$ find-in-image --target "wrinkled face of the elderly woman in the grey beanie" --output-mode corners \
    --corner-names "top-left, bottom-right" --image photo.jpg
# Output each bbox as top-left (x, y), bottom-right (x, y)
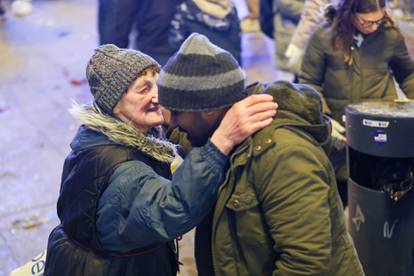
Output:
top-left (113, 70), bottom-right (164, 133)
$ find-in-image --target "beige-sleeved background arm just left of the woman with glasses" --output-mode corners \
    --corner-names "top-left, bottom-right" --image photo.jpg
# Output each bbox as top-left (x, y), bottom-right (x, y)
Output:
top-left (285, 0), bottom-right (330, 72)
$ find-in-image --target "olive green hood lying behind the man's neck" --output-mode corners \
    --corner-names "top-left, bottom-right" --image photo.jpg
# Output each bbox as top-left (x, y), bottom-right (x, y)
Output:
top-left (248, 81), bottom-right (331, 151)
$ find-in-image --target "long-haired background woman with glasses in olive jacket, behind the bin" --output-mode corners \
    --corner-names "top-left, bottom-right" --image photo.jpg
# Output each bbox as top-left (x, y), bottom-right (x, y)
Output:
top-left (300, 0), bottom-right (414, 206)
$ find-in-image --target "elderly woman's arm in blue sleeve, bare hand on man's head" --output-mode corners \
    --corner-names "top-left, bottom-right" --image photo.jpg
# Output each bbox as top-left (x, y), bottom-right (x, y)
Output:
top-left (96, 95), bottom-right (276, 252)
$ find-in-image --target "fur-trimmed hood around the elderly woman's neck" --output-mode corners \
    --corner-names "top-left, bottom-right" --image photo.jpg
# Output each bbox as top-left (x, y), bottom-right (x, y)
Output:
top-left (70, 104), bottom-right (177, 163)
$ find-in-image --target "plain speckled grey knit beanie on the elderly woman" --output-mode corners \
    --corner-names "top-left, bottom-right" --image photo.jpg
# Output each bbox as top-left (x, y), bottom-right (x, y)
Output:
top-left (86, 44), bottom-right (160, 115)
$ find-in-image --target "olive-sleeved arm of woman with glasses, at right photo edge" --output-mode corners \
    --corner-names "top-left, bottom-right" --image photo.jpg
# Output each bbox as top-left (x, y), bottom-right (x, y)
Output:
top-left (389, 30), bottom-right (414, 99)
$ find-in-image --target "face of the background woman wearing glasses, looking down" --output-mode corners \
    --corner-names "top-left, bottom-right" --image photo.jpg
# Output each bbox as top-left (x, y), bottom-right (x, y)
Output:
top-left (354, 9), bottom-right (387, 34)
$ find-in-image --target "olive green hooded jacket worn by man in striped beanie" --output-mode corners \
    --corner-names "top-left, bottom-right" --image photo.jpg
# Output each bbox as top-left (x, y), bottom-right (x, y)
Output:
top-left (196, 82), bottom-right (363, 276)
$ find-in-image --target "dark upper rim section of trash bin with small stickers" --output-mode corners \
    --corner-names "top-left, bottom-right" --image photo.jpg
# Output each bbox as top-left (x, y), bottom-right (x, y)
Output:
top-left (345, 101), bottom-right (414, 158)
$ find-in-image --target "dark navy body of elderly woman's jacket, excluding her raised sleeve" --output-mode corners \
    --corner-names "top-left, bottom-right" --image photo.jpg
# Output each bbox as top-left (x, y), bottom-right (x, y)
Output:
top-left (45, 145), bottom-right (178, 276)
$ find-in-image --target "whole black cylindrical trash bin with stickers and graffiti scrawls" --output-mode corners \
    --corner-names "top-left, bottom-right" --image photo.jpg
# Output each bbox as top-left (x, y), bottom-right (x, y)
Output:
top-left (346, 102), bottom-right (414, 276)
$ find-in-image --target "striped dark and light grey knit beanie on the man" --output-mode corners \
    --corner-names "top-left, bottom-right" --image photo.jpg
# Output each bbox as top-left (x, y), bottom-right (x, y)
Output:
top-left (157, 33), bottom-right (247, 112)
